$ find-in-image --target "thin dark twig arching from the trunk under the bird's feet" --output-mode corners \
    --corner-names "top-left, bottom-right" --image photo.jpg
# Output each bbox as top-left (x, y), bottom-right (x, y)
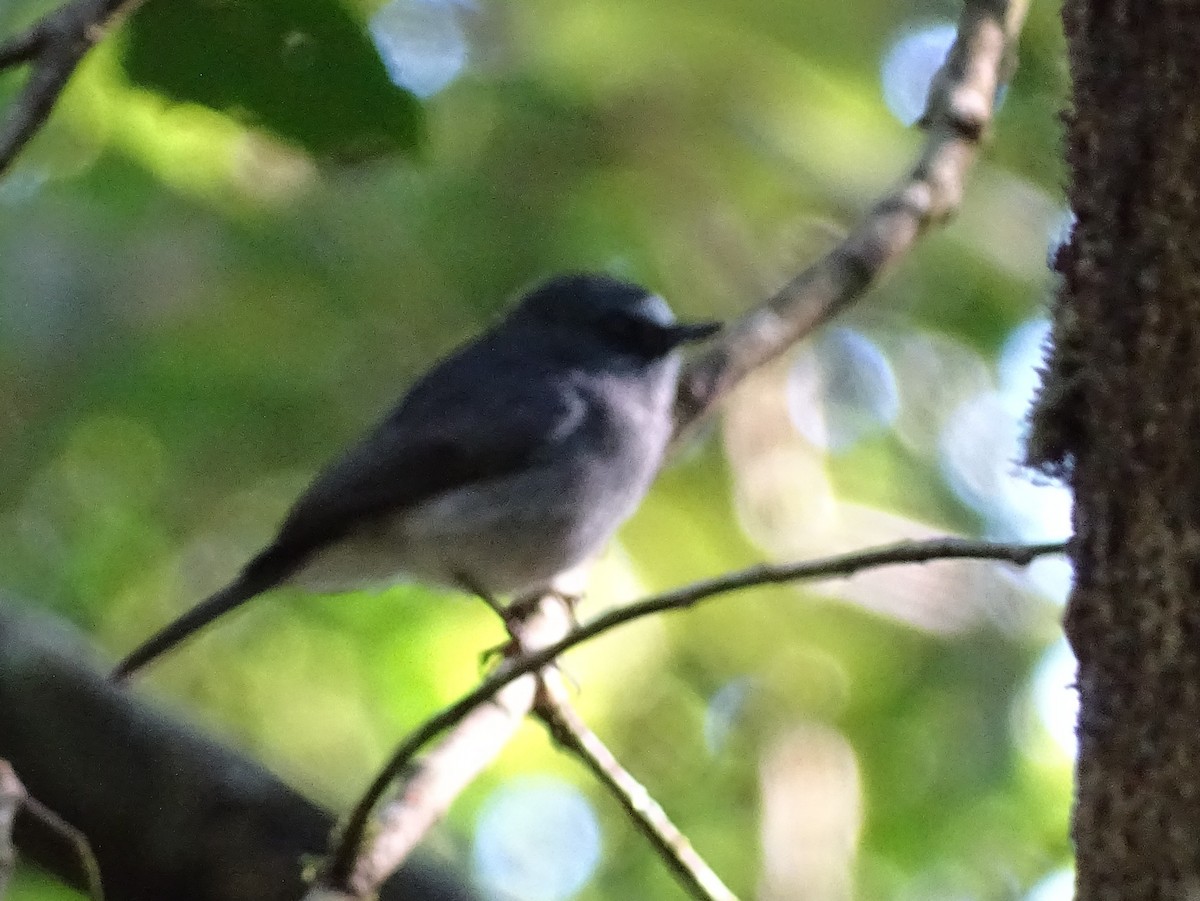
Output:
top-left (331, 539), bottom-right (1067, 884)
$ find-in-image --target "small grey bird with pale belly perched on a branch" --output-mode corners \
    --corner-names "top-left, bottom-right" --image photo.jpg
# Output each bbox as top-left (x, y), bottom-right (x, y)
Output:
top-left (112, 272), bottom-right (721, 683)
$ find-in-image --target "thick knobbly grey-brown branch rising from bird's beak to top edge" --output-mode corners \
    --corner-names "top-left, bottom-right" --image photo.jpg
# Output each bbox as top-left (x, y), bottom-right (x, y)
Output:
top-left (676, 0), bottom-right (1028, 437)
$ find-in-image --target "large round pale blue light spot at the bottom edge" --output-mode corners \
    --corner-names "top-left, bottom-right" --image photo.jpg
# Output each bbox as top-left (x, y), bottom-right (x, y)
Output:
top-left (472, 776), bottom-right (600, 901)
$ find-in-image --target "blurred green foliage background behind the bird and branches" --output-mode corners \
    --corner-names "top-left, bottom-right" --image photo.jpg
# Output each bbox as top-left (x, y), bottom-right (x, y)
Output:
top-left (0, 0), bottom-right (1070, 901)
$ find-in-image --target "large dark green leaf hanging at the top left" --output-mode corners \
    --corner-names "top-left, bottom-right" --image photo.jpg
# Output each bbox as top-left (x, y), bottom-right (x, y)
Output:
top-left (122, 0), bottom-right (421, 161)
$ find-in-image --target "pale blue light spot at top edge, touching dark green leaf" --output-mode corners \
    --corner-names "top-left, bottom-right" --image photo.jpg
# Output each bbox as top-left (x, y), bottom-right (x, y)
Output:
top-left (370, 0), bottom-right (474, 97)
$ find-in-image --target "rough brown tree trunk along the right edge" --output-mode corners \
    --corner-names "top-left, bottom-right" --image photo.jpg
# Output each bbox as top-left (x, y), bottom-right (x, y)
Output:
top-left (1031, 0), bottom-right (1200, 901)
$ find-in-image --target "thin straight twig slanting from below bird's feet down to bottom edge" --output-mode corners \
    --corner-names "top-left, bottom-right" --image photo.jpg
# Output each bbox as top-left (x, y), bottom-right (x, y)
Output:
top-left (533, 669), bottom-right (738, 901)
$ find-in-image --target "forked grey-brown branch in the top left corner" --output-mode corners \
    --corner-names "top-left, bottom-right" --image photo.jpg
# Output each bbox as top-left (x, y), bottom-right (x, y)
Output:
top-left (0, 0), bottom-right (143, 175)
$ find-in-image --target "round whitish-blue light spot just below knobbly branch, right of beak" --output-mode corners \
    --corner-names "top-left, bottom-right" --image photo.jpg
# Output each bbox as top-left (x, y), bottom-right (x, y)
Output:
top-left (787, 329), bottom-right (900, 453)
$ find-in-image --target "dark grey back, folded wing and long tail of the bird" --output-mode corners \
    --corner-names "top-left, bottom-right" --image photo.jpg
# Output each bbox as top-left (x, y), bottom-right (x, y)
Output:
top-left (113, 344), bottom-right (586, 681)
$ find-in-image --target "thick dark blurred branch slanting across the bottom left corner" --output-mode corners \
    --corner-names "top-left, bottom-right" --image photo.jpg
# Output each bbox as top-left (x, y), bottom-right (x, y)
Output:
top-left (0, 599), bottom-right (473, 901)
